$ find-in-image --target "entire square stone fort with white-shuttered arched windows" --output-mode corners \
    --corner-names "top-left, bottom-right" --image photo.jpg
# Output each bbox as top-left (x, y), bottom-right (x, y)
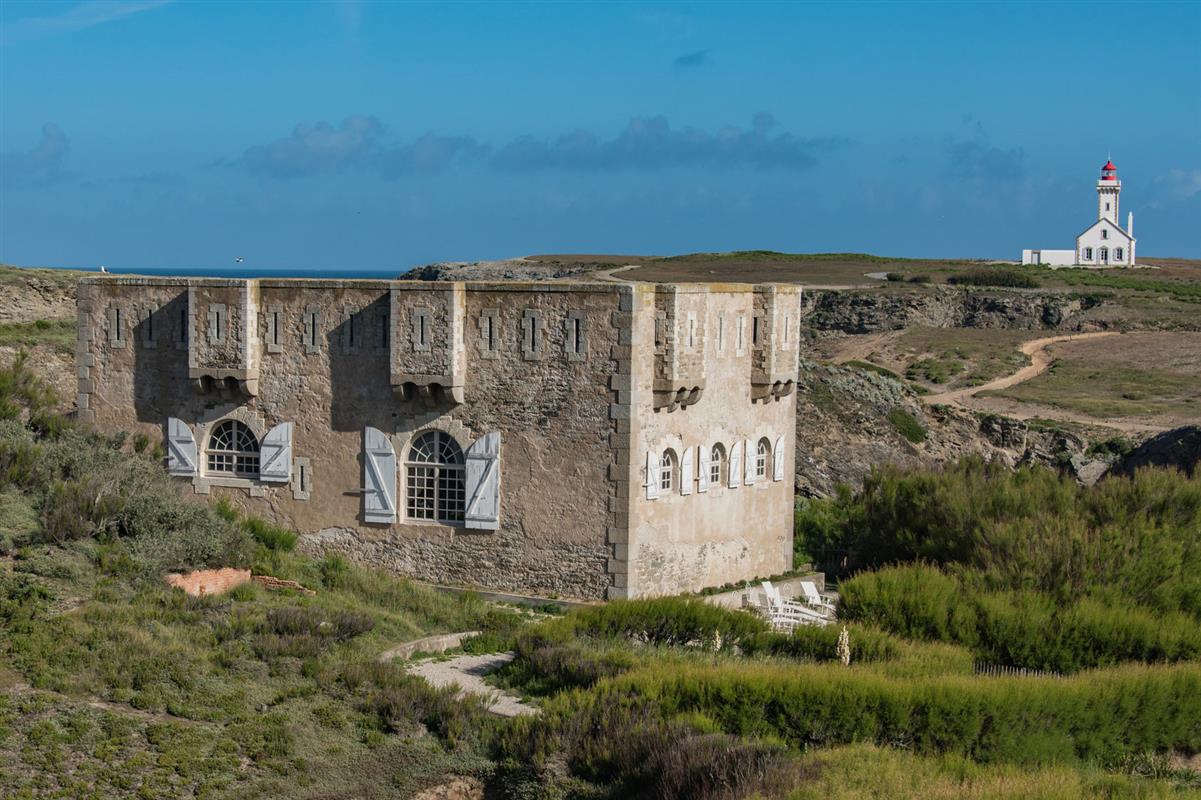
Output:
top-left (77, 276), bottom-right (801, 598)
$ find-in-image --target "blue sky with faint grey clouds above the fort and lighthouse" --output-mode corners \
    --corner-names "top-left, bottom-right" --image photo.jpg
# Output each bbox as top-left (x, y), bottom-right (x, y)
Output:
top-left (0, 0), bottom-right (1201, 270)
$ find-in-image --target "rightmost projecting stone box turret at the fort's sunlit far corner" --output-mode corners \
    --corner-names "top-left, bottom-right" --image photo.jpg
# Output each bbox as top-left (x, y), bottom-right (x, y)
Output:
top-left (751, 283), bottom-right (801, 402)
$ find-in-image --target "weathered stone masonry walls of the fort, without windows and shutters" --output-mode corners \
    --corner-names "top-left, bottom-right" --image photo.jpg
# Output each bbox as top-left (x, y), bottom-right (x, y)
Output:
top-left (77, 277), bottom-right (795, 598)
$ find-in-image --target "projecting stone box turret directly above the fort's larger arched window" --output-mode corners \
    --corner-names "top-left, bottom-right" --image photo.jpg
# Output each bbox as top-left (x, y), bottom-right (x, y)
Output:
top-left (390, 282), bottom-right (467, 407)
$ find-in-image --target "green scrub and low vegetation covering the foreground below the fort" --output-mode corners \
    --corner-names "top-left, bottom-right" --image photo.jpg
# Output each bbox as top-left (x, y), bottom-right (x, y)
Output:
top-left (0, 360), bottom-right (1201, 800)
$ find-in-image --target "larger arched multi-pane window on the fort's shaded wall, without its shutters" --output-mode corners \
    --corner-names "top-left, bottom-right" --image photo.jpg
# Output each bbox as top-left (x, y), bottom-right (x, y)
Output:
top-left (405, 430), bottom-right (467, 523)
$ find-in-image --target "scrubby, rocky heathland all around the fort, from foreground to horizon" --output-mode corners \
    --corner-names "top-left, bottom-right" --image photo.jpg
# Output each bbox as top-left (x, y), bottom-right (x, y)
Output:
top-left (0, 253), bottom-right (1201, 800)
